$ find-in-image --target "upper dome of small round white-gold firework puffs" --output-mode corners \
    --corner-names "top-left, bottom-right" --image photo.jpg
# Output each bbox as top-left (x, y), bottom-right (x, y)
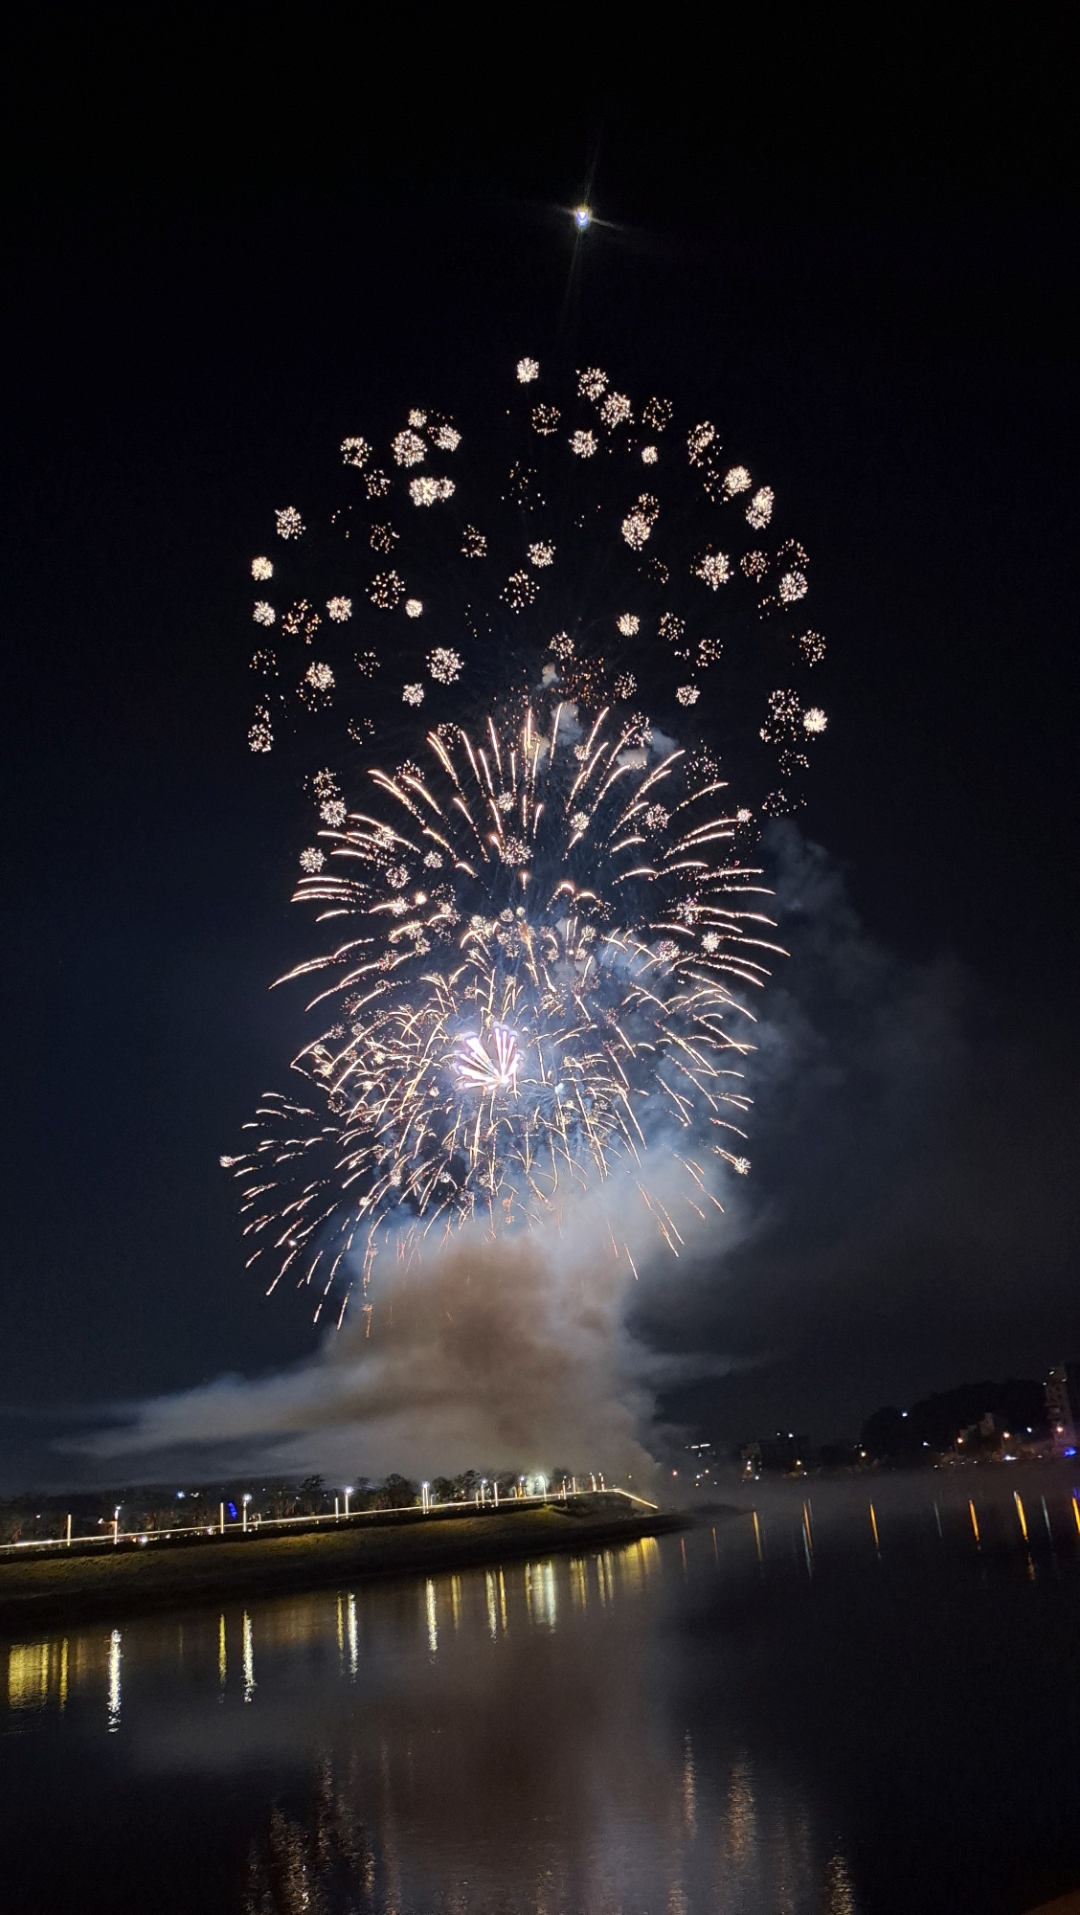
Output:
top-left (251, 358), bottom-right (825, 810)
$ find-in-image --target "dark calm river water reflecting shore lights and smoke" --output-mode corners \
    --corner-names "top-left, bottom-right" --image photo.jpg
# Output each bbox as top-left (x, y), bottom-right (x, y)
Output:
top-left (0, 1473), bottom-right (1080, 1915)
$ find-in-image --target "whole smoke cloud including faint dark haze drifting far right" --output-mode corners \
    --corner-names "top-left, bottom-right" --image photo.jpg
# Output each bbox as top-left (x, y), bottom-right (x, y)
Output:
top-left (50, 825), bottom-right (1080, 1486)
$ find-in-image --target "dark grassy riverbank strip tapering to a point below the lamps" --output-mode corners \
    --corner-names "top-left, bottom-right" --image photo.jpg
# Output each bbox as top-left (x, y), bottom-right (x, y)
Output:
top-left (0, 1503), bottom-right (686, 1633)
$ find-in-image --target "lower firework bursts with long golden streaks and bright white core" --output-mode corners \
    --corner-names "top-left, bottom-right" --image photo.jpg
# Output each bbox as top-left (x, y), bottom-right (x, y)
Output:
top-left (228, 703), bottom-right (776, 1308)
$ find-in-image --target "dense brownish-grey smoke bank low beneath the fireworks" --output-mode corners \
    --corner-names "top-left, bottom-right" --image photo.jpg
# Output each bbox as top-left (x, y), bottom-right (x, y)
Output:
top-left (69, 1178), bottom-right (742, 1494)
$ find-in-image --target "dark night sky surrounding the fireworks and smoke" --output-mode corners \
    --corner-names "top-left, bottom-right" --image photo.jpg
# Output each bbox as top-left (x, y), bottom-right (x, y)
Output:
top-left (0, 6), bottom-right (1080, 1475)
